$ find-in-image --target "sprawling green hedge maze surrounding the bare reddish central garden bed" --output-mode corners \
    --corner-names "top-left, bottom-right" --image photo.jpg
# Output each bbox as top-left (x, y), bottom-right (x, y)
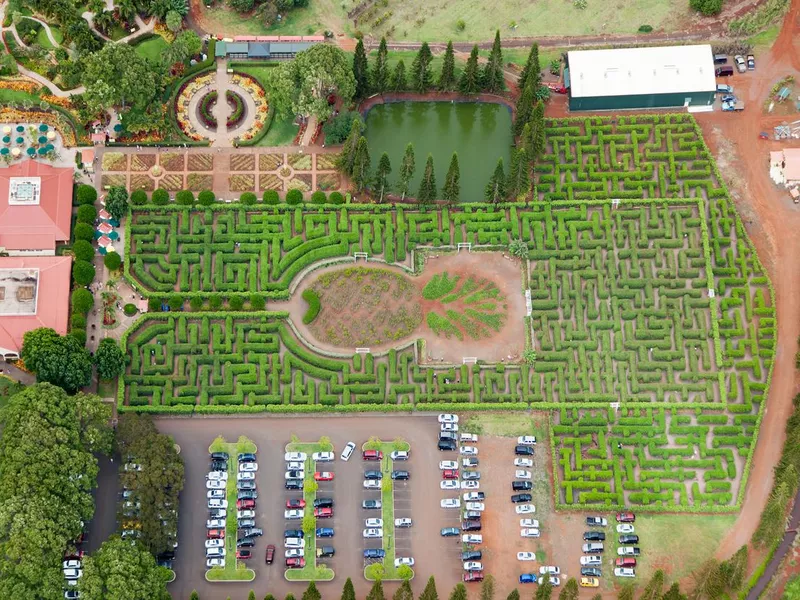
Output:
top-left (120, 115), bottom-right (777, 511)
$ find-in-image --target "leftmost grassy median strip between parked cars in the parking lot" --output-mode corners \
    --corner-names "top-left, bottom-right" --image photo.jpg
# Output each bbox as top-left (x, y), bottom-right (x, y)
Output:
top-left (206, 436), bottom-right (258, 581)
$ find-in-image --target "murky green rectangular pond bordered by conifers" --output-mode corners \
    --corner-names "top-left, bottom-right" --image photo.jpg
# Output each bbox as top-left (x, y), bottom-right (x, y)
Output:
top-left (366, 102), bottom-right (513, 202)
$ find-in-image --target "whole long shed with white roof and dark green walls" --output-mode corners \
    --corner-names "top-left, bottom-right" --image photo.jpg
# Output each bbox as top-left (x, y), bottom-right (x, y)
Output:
top-left (567, 44), bottom-right (717, 111)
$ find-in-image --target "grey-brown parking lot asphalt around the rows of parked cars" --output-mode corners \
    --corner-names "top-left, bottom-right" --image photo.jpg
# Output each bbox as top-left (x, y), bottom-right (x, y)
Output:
top-left (136, 416), bottom-right (461, 599)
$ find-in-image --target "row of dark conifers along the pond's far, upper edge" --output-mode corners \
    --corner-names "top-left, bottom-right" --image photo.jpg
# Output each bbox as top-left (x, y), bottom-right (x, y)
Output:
top-left (353, 30), bottom-right (505, 99)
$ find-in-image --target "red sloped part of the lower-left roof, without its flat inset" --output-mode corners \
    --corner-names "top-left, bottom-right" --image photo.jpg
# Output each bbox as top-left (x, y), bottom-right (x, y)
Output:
top-left (0, 256), bottom-right (72, 353)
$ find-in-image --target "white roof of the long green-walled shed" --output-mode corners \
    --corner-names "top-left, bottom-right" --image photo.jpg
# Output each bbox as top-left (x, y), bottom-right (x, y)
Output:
top-left (567, 44), bottom-right (717, 98)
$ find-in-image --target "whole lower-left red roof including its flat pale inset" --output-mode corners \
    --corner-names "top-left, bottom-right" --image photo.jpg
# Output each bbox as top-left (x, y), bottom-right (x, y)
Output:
top-left (0, 256), bottom-right (72, 356)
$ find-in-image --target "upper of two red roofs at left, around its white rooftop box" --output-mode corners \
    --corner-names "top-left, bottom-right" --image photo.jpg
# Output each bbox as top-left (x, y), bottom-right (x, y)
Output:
top-left (0, 160), bottom-right (73, 250)
